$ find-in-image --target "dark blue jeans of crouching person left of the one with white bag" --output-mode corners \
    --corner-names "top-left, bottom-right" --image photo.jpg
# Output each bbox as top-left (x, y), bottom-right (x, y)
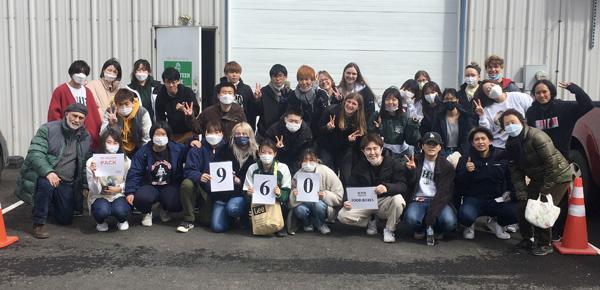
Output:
top-left (458, 196), bottom-right (517, 227)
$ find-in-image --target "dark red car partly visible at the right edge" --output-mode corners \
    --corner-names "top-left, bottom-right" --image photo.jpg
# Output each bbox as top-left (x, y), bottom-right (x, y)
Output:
top-left (569, 106), bottom-right (600, 211)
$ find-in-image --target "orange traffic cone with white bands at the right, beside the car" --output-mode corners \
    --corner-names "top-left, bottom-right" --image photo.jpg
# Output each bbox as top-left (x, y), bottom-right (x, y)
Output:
top-left (554, 177), bottom-right (598, 255)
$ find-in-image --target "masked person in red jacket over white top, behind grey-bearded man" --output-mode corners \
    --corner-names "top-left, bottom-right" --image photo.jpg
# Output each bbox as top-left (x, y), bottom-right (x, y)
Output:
top-left (48, 60), bottom-right (102, 148)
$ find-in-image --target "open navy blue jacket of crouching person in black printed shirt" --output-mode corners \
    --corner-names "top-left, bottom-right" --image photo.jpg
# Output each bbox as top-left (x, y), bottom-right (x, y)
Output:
top-left (125, 141), bottom-right (187, 195)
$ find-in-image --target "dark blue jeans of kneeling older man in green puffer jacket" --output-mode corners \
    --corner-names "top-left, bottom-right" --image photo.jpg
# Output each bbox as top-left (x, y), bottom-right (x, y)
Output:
top-left (33, 177), bottom-right (74, 225)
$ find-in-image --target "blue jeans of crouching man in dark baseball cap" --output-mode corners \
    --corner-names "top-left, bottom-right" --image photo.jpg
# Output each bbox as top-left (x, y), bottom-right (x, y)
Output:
top-left (404, 199), bottom-right (456, 233)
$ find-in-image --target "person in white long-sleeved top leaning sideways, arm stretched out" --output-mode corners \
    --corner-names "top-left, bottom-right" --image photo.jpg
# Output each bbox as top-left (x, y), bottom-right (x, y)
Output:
top-left (475, 80), bottom-right (533, 148)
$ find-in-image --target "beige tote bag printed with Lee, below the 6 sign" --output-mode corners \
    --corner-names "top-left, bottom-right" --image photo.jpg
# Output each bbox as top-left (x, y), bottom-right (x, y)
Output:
top-left (250, 202), bottom-right (284, 236)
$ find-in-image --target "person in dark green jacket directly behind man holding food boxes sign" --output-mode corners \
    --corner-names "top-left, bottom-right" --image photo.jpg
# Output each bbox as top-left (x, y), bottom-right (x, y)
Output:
top-left (367, 87), bottom-right (421, 156)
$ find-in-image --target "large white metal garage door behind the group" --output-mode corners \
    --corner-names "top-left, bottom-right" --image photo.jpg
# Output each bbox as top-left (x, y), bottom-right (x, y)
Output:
top-left (227, 0), bottom-right (459, 95)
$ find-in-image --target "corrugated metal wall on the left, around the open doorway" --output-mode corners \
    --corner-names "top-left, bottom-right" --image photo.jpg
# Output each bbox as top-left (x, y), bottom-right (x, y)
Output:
top-left (0, 0), bottom-right (225, 155)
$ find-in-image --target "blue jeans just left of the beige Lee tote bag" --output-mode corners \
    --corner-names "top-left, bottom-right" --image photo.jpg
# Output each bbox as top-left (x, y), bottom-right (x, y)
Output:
top-left (210, 196), bottom-right (248, 233)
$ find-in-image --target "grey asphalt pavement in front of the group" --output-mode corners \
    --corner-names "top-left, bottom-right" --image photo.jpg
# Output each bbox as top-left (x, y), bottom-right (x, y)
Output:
top-left (0, 170), bottom-right (600, 289)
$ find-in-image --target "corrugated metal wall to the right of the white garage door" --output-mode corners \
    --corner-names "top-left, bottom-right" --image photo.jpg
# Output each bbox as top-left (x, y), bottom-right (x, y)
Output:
top-left (465, 0), bottom-right (600, 101)
